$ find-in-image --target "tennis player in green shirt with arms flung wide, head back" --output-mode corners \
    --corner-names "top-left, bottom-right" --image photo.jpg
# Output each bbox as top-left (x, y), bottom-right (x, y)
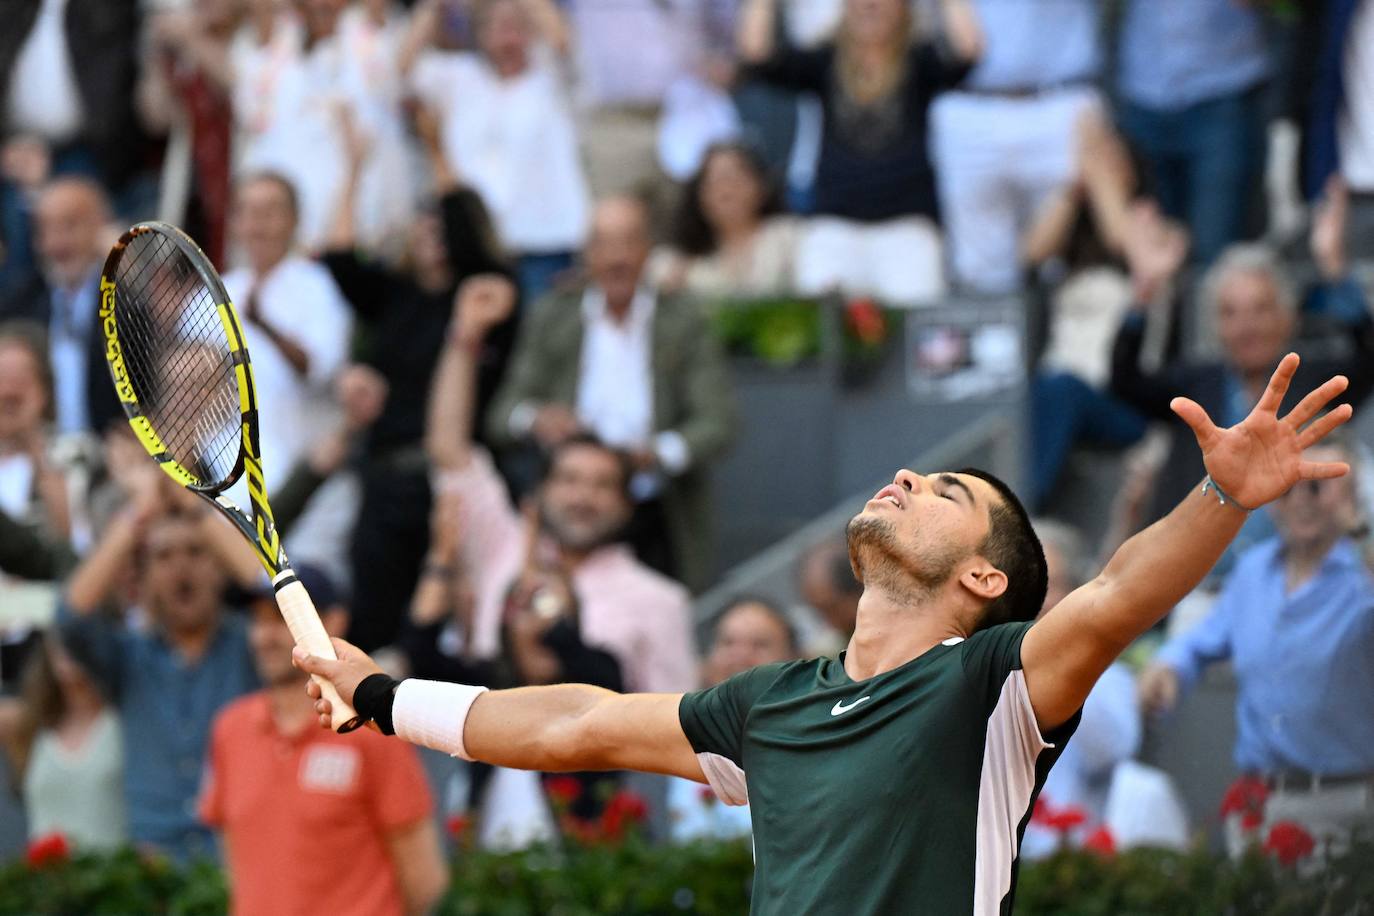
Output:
top-left (295, 354), bottom-right (1351, 915)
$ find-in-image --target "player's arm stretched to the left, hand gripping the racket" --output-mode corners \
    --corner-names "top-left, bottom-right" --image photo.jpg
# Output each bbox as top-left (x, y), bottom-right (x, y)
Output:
top-left (294, 639), bottom-right (706, 783)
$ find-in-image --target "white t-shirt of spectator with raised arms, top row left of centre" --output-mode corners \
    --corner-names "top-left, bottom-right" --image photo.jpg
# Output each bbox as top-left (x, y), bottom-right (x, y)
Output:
top-left (411, 47), bottom-right (591, 253)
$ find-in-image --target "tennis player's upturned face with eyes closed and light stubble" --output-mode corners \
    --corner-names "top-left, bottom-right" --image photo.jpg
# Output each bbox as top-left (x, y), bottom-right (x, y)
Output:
top-left (846, 470), bottom-right (999, 589)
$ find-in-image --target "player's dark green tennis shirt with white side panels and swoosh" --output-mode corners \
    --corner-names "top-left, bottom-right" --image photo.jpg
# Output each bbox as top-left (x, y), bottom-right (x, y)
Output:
top-left (679, 623), bottom-right (1079, 916)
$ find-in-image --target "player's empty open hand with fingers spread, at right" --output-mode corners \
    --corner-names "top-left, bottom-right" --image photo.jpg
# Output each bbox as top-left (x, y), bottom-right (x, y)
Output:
top-left (1169, 353), bottom-right (1352, 508)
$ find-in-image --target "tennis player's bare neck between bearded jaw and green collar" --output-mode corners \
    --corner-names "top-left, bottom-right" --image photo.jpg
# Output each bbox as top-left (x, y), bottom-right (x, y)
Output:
top-left (845, 586), bottom-right (965, 681)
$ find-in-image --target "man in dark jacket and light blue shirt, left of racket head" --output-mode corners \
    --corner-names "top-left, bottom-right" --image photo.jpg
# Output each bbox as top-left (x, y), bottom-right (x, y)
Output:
top-left (0, 177), bottom-right (124, 434)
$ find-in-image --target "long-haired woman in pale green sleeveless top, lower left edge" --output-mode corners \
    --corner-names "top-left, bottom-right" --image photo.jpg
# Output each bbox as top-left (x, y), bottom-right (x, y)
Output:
top-left (0, 636), bottom-right (128, 849)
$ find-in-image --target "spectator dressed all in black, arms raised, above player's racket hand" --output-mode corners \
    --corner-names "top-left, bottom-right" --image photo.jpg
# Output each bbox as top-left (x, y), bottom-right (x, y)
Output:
top-left (322, 109), bottom-right (515, 648)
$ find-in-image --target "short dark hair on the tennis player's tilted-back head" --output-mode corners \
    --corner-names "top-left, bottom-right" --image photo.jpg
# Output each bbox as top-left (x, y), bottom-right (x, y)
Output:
top-left (959, 467), bottom-right (1050, 629)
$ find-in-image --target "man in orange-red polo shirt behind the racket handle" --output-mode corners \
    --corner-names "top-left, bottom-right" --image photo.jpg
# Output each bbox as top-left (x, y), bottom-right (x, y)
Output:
top-left (201, 567), bottom-right (448, 916)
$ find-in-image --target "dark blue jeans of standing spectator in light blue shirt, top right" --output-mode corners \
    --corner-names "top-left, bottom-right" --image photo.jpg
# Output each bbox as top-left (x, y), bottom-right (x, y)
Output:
top-left (1118, 87), bottom-right (1267, 264)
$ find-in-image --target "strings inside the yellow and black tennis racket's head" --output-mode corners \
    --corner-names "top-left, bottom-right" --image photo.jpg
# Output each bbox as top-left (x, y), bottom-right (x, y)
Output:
top-left (114, 232), bottom-right (242, 486)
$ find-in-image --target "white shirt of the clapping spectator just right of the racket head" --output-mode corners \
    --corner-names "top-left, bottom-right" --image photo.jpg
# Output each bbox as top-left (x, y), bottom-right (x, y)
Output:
top-left (224, 255), bottom-right (353, 489)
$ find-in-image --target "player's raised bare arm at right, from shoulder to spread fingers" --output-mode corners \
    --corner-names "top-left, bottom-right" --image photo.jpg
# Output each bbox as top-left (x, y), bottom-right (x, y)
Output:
top-left (1021, 353), bottom-right (1351, 731)
